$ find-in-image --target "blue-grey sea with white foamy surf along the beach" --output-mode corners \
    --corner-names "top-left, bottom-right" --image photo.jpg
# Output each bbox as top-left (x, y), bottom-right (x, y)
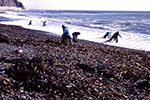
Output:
top-left (0, 10), bottom-right (150, 51)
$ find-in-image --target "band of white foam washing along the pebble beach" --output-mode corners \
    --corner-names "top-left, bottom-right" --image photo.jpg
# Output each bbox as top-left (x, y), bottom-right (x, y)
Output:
top-left (0, 13), bottom-right (150, 51)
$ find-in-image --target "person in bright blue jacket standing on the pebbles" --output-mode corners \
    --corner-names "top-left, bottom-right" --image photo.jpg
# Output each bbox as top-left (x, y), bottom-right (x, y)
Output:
top-left (61, 25), bottom-right (72, 44)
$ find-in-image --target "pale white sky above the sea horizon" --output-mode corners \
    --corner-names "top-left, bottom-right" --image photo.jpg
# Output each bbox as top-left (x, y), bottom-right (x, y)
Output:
top-left (18, 0), bottom-right (150, 11)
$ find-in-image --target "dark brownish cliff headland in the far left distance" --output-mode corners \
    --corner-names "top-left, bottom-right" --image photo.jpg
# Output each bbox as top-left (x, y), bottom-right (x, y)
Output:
top-left (0, 0), bottom-right (25, 9)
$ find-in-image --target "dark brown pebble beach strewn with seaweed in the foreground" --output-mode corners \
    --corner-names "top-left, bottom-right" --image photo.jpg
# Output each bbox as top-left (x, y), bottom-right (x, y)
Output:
top-left (0, 24), bottom-right (150, 100)
